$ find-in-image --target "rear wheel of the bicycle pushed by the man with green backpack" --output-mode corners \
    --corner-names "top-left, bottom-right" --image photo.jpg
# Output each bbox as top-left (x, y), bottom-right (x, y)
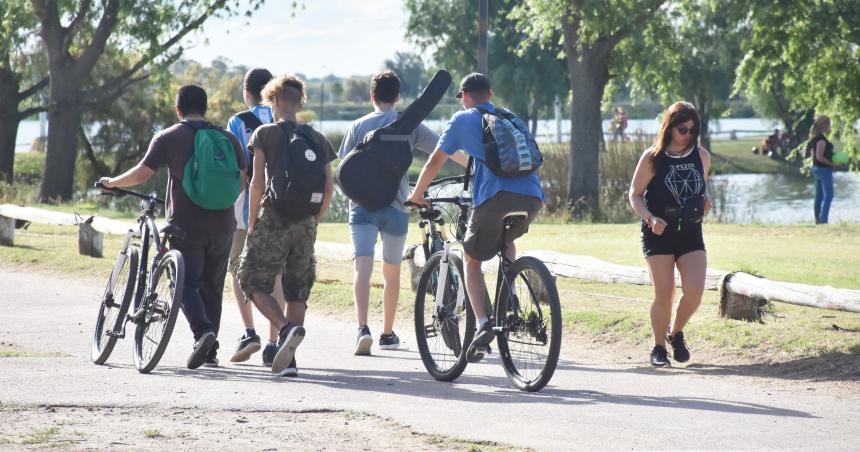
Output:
top-left (134, 250), bottom-right (185, 373)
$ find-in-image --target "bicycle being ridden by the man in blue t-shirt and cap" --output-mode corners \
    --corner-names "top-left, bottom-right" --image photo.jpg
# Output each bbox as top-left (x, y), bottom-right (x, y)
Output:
top-left (415, 176), bottom-right (562, 392)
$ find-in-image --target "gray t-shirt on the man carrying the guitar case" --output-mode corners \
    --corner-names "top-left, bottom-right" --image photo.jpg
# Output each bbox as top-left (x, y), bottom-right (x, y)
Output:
top-left (337, 111), bottom-right (439, 212)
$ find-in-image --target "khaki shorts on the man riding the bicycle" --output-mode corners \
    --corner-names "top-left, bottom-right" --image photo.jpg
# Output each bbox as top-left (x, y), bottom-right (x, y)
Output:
top-left (463, 191), bottom-right (543, 261)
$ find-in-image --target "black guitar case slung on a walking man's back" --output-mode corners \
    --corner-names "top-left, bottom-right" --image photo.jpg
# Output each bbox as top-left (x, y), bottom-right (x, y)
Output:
top-left (336, 70), bottom-right (451, 210)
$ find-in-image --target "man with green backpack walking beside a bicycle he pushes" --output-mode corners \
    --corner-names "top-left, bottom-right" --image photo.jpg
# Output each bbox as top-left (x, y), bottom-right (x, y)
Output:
top-left (99, 85), bottom-right (247, 369)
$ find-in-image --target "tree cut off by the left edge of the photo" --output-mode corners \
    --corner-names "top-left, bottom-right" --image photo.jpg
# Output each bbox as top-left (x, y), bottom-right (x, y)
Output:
top-left (0, 0), bottom-right (48, 183)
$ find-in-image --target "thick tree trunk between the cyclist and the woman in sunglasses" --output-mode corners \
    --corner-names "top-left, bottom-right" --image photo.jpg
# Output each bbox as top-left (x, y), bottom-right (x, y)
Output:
top-left (567, 48), bottom-right (609, 220)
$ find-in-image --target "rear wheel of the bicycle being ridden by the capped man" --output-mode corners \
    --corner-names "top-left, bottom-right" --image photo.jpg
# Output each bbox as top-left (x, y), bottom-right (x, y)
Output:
top-left (496, 256), bottom-right (561, 392)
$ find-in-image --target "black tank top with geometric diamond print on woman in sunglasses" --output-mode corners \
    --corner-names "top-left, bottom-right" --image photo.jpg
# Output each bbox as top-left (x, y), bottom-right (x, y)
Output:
top-left (642, 146), bottom-right (705, 230)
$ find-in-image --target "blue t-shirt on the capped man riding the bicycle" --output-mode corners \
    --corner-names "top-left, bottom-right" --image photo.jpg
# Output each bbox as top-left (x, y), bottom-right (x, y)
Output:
top-left (438, 102), bottom-right (546, 207)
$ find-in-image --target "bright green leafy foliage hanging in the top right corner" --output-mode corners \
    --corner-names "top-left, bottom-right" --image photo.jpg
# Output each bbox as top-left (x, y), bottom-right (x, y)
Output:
top-left (736, 0), bottom-right (860, 152)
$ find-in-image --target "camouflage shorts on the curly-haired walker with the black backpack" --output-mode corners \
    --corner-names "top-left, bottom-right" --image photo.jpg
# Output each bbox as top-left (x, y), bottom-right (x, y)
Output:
top-left (238, 207), bottom-right (317, 301)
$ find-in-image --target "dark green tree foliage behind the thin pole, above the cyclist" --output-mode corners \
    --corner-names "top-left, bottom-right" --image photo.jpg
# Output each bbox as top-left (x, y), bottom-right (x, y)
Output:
top-left (406, 0), bottom-right (567, 136)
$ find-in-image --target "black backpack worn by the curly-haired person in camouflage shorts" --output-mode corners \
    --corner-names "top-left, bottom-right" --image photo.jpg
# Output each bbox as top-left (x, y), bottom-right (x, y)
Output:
top-left (266, 122), bottom-right (328, 219)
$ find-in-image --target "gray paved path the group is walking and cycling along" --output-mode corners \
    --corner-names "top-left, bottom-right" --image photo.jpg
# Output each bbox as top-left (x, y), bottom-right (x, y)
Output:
top-left (0, 271), bottom-right (860, 450)
